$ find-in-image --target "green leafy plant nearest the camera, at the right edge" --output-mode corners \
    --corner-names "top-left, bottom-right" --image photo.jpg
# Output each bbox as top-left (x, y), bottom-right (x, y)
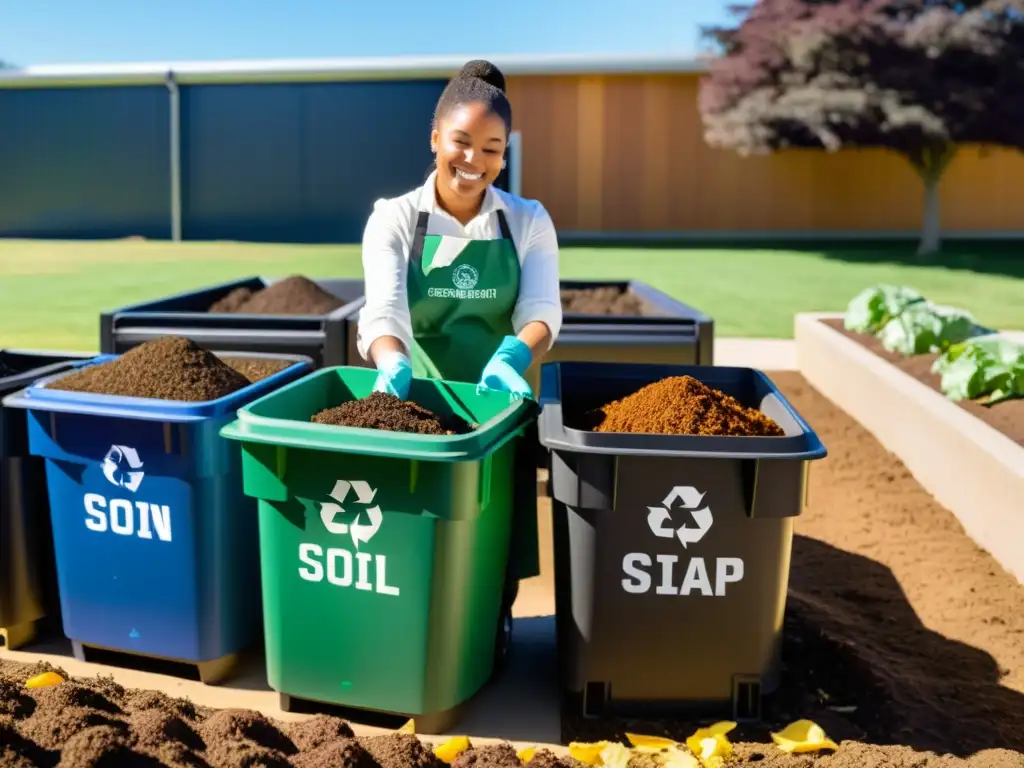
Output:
top-left (932, 336), bottom-right (1024, 406)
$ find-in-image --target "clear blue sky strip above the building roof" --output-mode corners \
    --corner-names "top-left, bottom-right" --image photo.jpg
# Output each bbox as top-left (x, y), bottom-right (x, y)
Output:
top-left (0, 0), bottom-right (728, 66)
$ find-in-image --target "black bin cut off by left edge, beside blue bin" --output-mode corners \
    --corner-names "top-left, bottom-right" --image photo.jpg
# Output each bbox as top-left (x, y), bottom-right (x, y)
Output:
top-left (0, 349), bottom-right (95, 648)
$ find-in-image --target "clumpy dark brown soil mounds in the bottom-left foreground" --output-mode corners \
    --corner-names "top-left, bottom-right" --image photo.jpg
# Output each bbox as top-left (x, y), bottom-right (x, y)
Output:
top-left (0, 660), bottom-right (483, 768)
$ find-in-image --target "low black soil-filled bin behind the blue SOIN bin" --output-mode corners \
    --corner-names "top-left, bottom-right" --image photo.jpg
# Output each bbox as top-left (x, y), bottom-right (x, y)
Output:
top-left (99, 278), bottom-right (364, 368)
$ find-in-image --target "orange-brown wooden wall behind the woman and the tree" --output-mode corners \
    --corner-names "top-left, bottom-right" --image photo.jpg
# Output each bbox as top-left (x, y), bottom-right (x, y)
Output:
top-left (509, 75), bottom-right (1024, 233)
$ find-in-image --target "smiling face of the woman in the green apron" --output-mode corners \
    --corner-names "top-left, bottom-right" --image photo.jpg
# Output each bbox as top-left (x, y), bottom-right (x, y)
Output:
top-left (430, 103), bottom-right (506, 204)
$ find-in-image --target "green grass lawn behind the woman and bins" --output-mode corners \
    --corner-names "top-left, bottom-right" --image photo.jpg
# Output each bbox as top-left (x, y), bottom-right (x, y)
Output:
top-left (0, 240), bottom-right (1024, 350)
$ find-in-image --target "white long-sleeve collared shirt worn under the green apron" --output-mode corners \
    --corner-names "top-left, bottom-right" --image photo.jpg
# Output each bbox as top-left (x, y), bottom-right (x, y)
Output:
top-left (358, 172), bottom-right (562, 359)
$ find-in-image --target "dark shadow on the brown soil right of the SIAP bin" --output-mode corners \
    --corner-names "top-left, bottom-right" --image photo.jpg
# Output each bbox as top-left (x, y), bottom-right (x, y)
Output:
top-left (562, 536), bottom-right (1024, 757)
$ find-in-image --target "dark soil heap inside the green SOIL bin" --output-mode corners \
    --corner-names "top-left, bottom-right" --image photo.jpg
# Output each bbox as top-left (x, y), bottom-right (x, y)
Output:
top-left (312, 392), bottom-right (473, 435)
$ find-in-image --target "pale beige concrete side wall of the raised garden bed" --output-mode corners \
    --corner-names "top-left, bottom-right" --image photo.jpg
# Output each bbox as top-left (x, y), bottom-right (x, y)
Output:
top-left (795, 312), bottom-right (1024, 583)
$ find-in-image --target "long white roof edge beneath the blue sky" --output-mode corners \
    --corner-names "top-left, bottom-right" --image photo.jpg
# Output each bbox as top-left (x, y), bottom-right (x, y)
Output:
top-left (0, 53), bottom-right (706, 88)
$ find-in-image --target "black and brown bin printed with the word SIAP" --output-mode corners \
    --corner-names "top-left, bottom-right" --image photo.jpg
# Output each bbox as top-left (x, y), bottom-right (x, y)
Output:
top-left (539, 362), bottom-right (825, 720)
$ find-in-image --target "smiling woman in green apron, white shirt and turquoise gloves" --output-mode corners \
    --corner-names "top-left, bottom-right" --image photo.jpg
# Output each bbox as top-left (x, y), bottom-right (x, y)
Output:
top-left (358, 60), bottom-right (562, 653)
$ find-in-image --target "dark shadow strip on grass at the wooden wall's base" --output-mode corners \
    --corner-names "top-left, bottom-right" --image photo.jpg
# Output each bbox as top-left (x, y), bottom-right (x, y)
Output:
top-left (563, 239), bottom-right (1024, 279)
